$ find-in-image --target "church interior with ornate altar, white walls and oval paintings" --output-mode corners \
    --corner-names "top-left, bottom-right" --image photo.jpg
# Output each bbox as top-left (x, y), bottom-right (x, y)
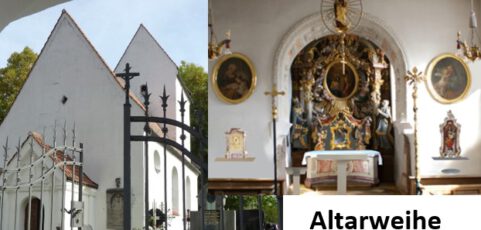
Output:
top-left (208, 0), bottom-right (481, 199)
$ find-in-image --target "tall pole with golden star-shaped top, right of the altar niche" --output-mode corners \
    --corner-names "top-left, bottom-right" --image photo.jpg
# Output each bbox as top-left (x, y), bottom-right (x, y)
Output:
top-left (404, 67), bottom-right (424, 195)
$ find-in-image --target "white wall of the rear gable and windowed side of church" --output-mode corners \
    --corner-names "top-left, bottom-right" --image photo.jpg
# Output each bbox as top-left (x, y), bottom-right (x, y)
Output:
top-left (115, 26), bottom-right (199, 226)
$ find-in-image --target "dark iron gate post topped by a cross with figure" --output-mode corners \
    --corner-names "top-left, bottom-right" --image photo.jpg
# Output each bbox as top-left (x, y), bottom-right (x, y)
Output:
top-left (116, 63), bottom-right (140, 229)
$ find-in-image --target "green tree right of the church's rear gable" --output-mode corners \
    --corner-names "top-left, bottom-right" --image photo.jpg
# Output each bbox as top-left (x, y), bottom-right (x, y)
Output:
top-left (179, 61), bottom-right (208, 160)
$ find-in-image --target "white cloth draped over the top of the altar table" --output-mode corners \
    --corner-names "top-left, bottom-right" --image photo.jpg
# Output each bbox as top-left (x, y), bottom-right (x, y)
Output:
top-left (302, 150), bottom-right (382, 165)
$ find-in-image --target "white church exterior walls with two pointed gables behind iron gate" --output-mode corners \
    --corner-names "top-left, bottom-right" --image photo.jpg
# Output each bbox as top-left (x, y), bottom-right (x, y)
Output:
top-left (0, 11), bottom-right (198, 229)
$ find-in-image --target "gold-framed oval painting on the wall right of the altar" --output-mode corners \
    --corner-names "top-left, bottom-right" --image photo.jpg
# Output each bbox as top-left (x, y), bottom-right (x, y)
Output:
top-left (425, 53), bottom-right (471, 104)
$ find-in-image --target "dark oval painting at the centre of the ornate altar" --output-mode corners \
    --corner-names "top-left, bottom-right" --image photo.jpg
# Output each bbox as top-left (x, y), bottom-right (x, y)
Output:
top-left (324, 61), bottom-right (359, 100)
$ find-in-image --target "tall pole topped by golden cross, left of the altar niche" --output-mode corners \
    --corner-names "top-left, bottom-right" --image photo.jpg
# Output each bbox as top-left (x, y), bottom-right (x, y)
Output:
top-left (264, 84), bottom-right (286, 230)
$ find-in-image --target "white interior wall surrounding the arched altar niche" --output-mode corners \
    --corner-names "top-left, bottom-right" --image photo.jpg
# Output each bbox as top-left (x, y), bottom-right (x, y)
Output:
top-left (209, 0), bottom-right (481, 190)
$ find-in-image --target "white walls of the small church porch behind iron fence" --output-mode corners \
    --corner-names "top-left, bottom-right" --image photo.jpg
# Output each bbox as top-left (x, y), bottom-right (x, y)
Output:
top-left (0, 139), bottom-right (98, 229)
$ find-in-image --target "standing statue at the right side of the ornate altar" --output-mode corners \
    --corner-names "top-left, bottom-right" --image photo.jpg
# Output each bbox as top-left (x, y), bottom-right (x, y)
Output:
top-left (376, 100), bottom-right (392, 149)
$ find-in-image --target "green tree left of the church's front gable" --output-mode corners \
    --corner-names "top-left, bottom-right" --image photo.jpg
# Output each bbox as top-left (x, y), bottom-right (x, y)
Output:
top-left (0, 47), bottom-right (37, 123)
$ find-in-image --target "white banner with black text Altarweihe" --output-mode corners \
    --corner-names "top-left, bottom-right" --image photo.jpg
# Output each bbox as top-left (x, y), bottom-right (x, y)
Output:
top-left (284, 195), bottom-right (481, 230)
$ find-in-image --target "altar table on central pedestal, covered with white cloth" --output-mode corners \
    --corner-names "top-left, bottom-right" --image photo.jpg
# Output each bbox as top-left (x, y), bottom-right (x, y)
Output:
top-left (302, 150), bottom-right (382, 194)
